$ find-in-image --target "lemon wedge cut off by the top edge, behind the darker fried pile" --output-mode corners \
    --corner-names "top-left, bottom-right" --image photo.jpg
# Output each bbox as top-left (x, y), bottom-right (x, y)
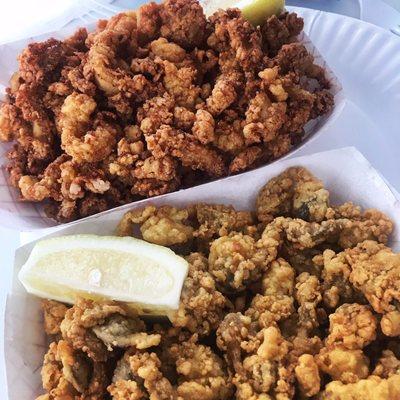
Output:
top-left (204, 0), bottom-right (285, 26)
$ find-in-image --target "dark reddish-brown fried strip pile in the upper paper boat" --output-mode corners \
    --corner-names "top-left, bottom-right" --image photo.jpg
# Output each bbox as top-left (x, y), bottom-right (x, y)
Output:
top-left (0, 0), bottom-right (333, 222)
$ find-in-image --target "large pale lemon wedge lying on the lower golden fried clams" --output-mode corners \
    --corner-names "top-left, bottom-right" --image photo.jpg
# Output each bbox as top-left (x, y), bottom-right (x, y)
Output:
top-left (18, 235), bottom-right (188, 315)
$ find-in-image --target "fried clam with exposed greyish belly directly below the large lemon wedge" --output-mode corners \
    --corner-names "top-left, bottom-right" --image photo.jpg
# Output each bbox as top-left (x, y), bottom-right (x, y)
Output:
top-left (61, 299), bottom-right (161, 361)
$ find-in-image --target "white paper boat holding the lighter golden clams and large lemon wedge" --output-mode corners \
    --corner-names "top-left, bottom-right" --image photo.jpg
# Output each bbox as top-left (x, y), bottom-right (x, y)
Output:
top-left (4, 147), bottom-right (400, 400)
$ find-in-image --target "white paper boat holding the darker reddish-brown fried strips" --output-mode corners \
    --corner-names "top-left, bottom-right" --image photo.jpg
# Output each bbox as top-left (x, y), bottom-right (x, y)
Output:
top-left (0, 10), bottom-right (345, 231)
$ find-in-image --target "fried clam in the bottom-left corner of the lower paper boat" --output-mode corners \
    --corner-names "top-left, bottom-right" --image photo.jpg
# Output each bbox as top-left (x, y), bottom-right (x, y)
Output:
top-left (38, 340), bottom-right (107, 400)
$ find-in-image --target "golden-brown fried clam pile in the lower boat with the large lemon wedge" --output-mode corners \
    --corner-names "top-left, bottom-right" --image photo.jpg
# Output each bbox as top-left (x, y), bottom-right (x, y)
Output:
top-left (35, 167), bottom-right (400, 400)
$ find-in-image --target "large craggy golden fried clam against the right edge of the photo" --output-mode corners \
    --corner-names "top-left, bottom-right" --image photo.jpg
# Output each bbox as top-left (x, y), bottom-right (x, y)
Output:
top-left (346, 240), bottom-right (400, 337)
